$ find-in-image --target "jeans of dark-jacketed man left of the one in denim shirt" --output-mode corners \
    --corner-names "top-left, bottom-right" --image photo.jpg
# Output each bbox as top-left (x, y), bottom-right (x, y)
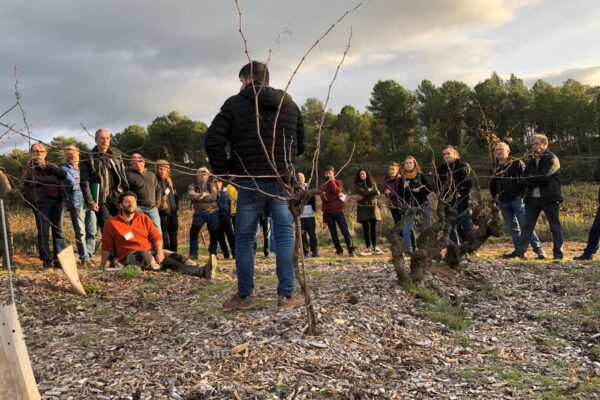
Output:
top-left (35, 198), bottom-right (65, 266)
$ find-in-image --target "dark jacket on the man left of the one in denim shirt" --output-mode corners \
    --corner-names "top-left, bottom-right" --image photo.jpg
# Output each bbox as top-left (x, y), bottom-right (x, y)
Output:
top-left (23, 163), bottom-right (67, 208)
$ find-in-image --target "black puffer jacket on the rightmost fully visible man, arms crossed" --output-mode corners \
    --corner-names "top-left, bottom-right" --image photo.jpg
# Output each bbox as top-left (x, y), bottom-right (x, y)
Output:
top-left (519, 150), bottom-right (563, 202)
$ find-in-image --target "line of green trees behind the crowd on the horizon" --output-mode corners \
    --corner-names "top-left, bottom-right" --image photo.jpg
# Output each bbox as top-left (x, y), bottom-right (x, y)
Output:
top-left (0, 72), bottom-right (600, 183)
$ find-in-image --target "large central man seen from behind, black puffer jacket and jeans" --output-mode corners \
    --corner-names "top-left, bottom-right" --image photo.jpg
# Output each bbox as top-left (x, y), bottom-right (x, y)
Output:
top-left (205, 61), bottom-right (304, 311)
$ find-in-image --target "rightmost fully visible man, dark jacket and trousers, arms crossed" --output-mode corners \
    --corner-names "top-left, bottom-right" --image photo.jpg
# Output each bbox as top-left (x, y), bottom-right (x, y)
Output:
top-left (506, 134), bottom-right (564, 260)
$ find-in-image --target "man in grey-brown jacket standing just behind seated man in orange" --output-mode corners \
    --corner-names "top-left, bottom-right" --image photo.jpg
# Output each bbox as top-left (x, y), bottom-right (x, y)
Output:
top-left (127, 153), bottom-right (162, 232)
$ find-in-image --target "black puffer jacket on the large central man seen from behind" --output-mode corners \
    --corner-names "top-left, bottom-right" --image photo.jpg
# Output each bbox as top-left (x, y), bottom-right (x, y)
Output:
top-left (204, 83), bottom-right (304, 176)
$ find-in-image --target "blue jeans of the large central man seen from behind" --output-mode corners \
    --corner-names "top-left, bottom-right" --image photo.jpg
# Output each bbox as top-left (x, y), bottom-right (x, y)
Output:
top-left (235, 179), bottom-right (294, 297)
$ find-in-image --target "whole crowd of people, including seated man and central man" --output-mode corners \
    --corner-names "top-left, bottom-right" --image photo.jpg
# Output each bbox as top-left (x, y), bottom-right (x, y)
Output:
top-left (0, 62), bottom-right (600, 311)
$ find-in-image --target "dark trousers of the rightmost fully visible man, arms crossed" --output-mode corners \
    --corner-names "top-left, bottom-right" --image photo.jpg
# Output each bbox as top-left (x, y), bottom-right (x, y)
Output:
top-left (515, 197), bottom-right (563, 256)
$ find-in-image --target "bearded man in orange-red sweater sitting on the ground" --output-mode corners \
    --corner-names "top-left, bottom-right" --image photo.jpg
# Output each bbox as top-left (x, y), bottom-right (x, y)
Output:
top-left (100, 192), bottom-right (217, 279)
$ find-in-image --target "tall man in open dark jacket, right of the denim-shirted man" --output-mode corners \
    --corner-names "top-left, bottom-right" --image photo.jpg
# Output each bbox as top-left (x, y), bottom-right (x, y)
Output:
top-left (79, 129), bottom-right (129, 229)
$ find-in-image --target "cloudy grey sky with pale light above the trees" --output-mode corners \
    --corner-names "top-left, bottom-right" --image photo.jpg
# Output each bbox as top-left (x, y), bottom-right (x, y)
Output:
top-left (0, 0), bottom-right (600, 150)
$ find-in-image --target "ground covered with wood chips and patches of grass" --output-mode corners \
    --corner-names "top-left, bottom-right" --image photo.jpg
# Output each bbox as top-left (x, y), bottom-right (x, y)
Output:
top-left (0, 244), bottom-right (600, 400)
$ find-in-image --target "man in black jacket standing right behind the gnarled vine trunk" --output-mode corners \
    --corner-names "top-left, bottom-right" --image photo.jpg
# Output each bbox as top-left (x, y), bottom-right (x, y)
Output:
top-left (437, 145), bottom-right (473, 245)
